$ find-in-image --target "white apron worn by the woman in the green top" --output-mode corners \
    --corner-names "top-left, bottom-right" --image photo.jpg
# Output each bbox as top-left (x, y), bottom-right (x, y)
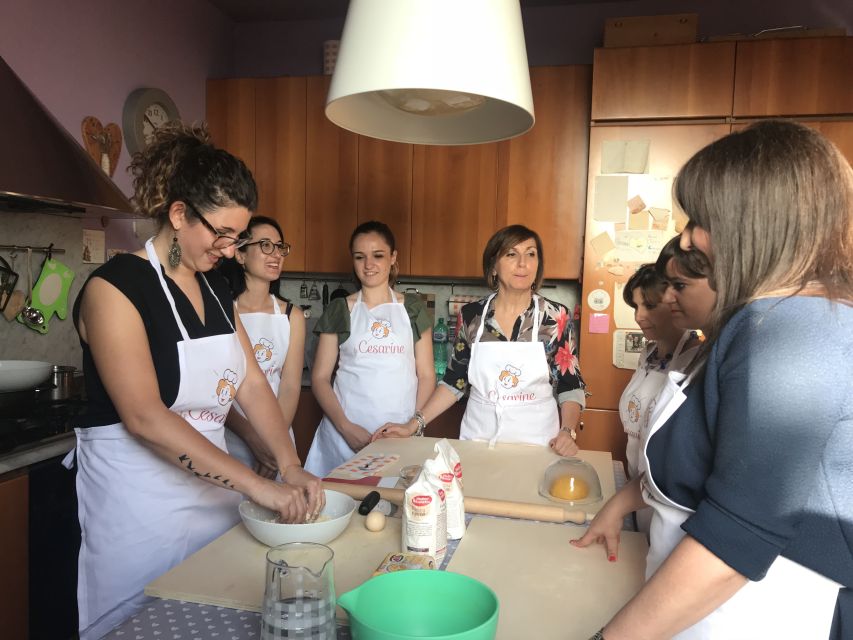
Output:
top-left (305, 291), bottom-right (418, 478)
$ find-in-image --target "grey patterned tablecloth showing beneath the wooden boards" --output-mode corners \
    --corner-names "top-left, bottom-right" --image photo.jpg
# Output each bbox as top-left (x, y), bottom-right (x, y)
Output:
top-left (104, 461), bottom-right (634, 640)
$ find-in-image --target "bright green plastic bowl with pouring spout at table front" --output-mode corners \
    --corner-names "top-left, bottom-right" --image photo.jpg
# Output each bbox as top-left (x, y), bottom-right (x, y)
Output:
top-left (338, 570), bottom-right (498, 640)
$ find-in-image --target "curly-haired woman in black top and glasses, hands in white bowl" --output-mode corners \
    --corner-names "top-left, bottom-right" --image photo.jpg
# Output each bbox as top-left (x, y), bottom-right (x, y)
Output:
top-left (74, 124), bottom-right (323, 640)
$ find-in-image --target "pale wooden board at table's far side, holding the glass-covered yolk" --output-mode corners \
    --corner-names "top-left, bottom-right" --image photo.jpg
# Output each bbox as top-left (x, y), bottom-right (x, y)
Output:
top-left (342, 438), bottom-right (616, 514)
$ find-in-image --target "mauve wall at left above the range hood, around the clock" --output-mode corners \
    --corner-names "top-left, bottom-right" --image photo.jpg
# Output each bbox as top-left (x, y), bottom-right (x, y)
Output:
top-left (0, 0), bottom-right (233, 194)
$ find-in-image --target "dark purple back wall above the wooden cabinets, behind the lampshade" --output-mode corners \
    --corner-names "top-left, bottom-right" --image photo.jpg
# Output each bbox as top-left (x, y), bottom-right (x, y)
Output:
top-left (228, 0), bottom-right (853, 77)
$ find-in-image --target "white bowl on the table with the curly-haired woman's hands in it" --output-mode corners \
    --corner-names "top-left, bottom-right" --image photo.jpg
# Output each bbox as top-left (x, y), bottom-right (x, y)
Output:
top-left (240, 489), bottom-right (356, 547)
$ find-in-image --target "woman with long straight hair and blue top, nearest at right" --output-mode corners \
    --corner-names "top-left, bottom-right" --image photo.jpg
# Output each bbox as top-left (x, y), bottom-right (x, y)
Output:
top-left (584, 121), bottom-right (853, 640)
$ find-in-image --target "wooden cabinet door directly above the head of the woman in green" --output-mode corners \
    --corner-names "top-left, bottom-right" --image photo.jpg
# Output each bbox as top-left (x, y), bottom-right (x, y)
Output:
top-left (358, 136), bottom-right (412, 274)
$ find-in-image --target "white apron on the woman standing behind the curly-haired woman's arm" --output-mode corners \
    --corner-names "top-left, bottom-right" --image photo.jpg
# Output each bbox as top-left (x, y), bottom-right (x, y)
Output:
top-left (225, 294), bottom-right (296, 469)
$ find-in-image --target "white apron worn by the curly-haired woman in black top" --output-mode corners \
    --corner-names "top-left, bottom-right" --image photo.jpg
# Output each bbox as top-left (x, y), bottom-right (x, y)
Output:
top-left (71, 240), bottom-right (246, 640)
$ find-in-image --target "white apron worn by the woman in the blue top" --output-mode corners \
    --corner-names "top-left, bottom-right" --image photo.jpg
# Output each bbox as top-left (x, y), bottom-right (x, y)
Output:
top-left (640, 371), bottom-right (839, 640)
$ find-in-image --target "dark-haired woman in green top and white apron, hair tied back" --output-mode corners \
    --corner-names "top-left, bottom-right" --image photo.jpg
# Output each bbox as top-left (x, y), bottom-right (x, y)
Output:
top-left (305, 222), bottom-right (435, 476)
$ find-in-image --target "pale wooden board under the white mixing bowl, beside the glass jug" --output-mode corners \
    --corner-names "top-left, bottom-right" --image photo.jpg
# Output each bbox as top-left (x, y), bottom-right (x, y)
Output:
top-left (145, 513), bottom-right (401, 619)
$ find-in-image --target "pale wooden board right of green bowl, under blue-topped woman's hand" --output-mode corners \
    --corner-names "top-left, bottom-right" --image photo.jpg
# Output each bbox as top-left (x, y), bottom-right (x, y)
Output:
top-left (447, 517), bottom-right (648, 640)
